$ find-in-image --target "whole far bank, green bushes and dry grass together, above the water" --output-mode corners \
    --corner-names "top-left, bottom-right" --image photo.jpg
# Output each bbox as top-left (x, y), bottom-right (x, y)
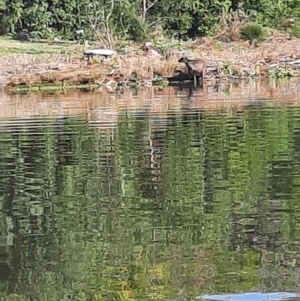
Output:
top-left (0, 0), bottom-right (300, 89)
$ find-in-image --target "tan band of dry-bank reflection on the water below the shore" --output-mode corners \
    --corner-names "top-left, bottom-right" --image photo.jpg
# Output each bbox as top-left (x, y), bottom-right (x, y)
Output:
top-left (0, 80), bottom-right (300, 130)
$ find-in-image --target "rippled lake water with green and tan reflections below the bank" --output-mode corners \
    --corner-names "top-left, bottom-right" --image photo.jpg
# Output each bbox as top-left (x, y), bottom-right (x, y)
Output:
top-left (0, 82), bottom-right (300, 301)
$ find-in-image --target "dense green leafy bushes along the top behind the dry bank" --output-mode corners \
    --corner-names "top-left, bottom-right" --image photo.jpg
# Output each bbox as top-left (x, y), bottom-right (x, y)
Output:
top-left (0, 0), bottom-right (300, 45)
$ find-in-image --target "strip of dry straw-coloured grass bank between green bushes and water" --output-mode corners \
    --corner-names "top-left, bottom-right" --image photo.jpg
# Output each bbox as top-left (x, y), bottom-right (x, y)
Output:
top-left (0, 32), bottom-right (300, 93)
